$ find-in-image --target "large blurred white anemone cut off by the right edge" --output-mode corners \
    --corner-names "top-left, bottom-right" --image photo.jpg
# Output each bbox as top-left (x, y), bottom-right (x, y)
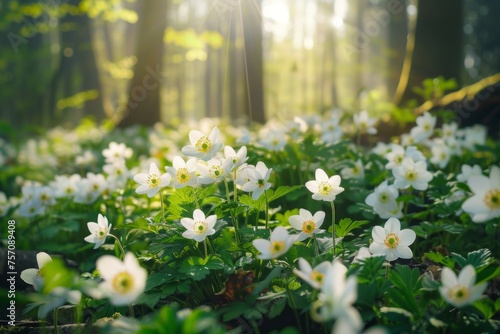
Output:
top-left (462, 166), bottom-right (500, 223)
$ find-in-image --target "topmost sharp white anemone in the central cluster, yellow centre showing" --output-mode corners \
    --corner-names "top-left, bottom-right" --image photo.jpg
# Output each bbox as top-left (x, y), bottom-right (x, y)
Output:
top-left (181, 127), bottom-right (222, 161)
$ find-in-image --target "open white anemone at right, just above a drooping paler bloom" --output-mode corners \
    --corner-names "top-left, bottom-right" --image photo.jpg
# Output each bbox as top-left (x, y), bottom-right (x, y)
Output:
top-left (392, 158), bottom-right (432, 190)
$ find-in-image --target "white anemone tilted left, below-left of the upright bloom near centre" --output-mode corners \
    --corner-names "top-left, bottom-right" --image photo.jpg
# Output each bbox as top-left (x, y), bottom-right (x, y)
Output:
top-left (252, 226), bottom-right (296, 260)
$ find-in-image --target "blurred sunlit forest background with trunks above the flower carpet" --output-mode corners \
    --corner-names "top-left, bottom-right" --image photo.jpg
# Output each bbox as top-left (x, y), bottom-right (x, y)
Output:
top-left (0, 0), bottom-right (500, 133)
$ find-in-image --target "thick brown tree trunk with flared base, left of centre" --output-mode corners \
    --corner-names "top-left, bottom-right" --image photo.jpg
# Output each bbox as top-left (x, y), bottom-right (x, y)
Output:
top-left (118, 1), bottom-right (167, 127)
